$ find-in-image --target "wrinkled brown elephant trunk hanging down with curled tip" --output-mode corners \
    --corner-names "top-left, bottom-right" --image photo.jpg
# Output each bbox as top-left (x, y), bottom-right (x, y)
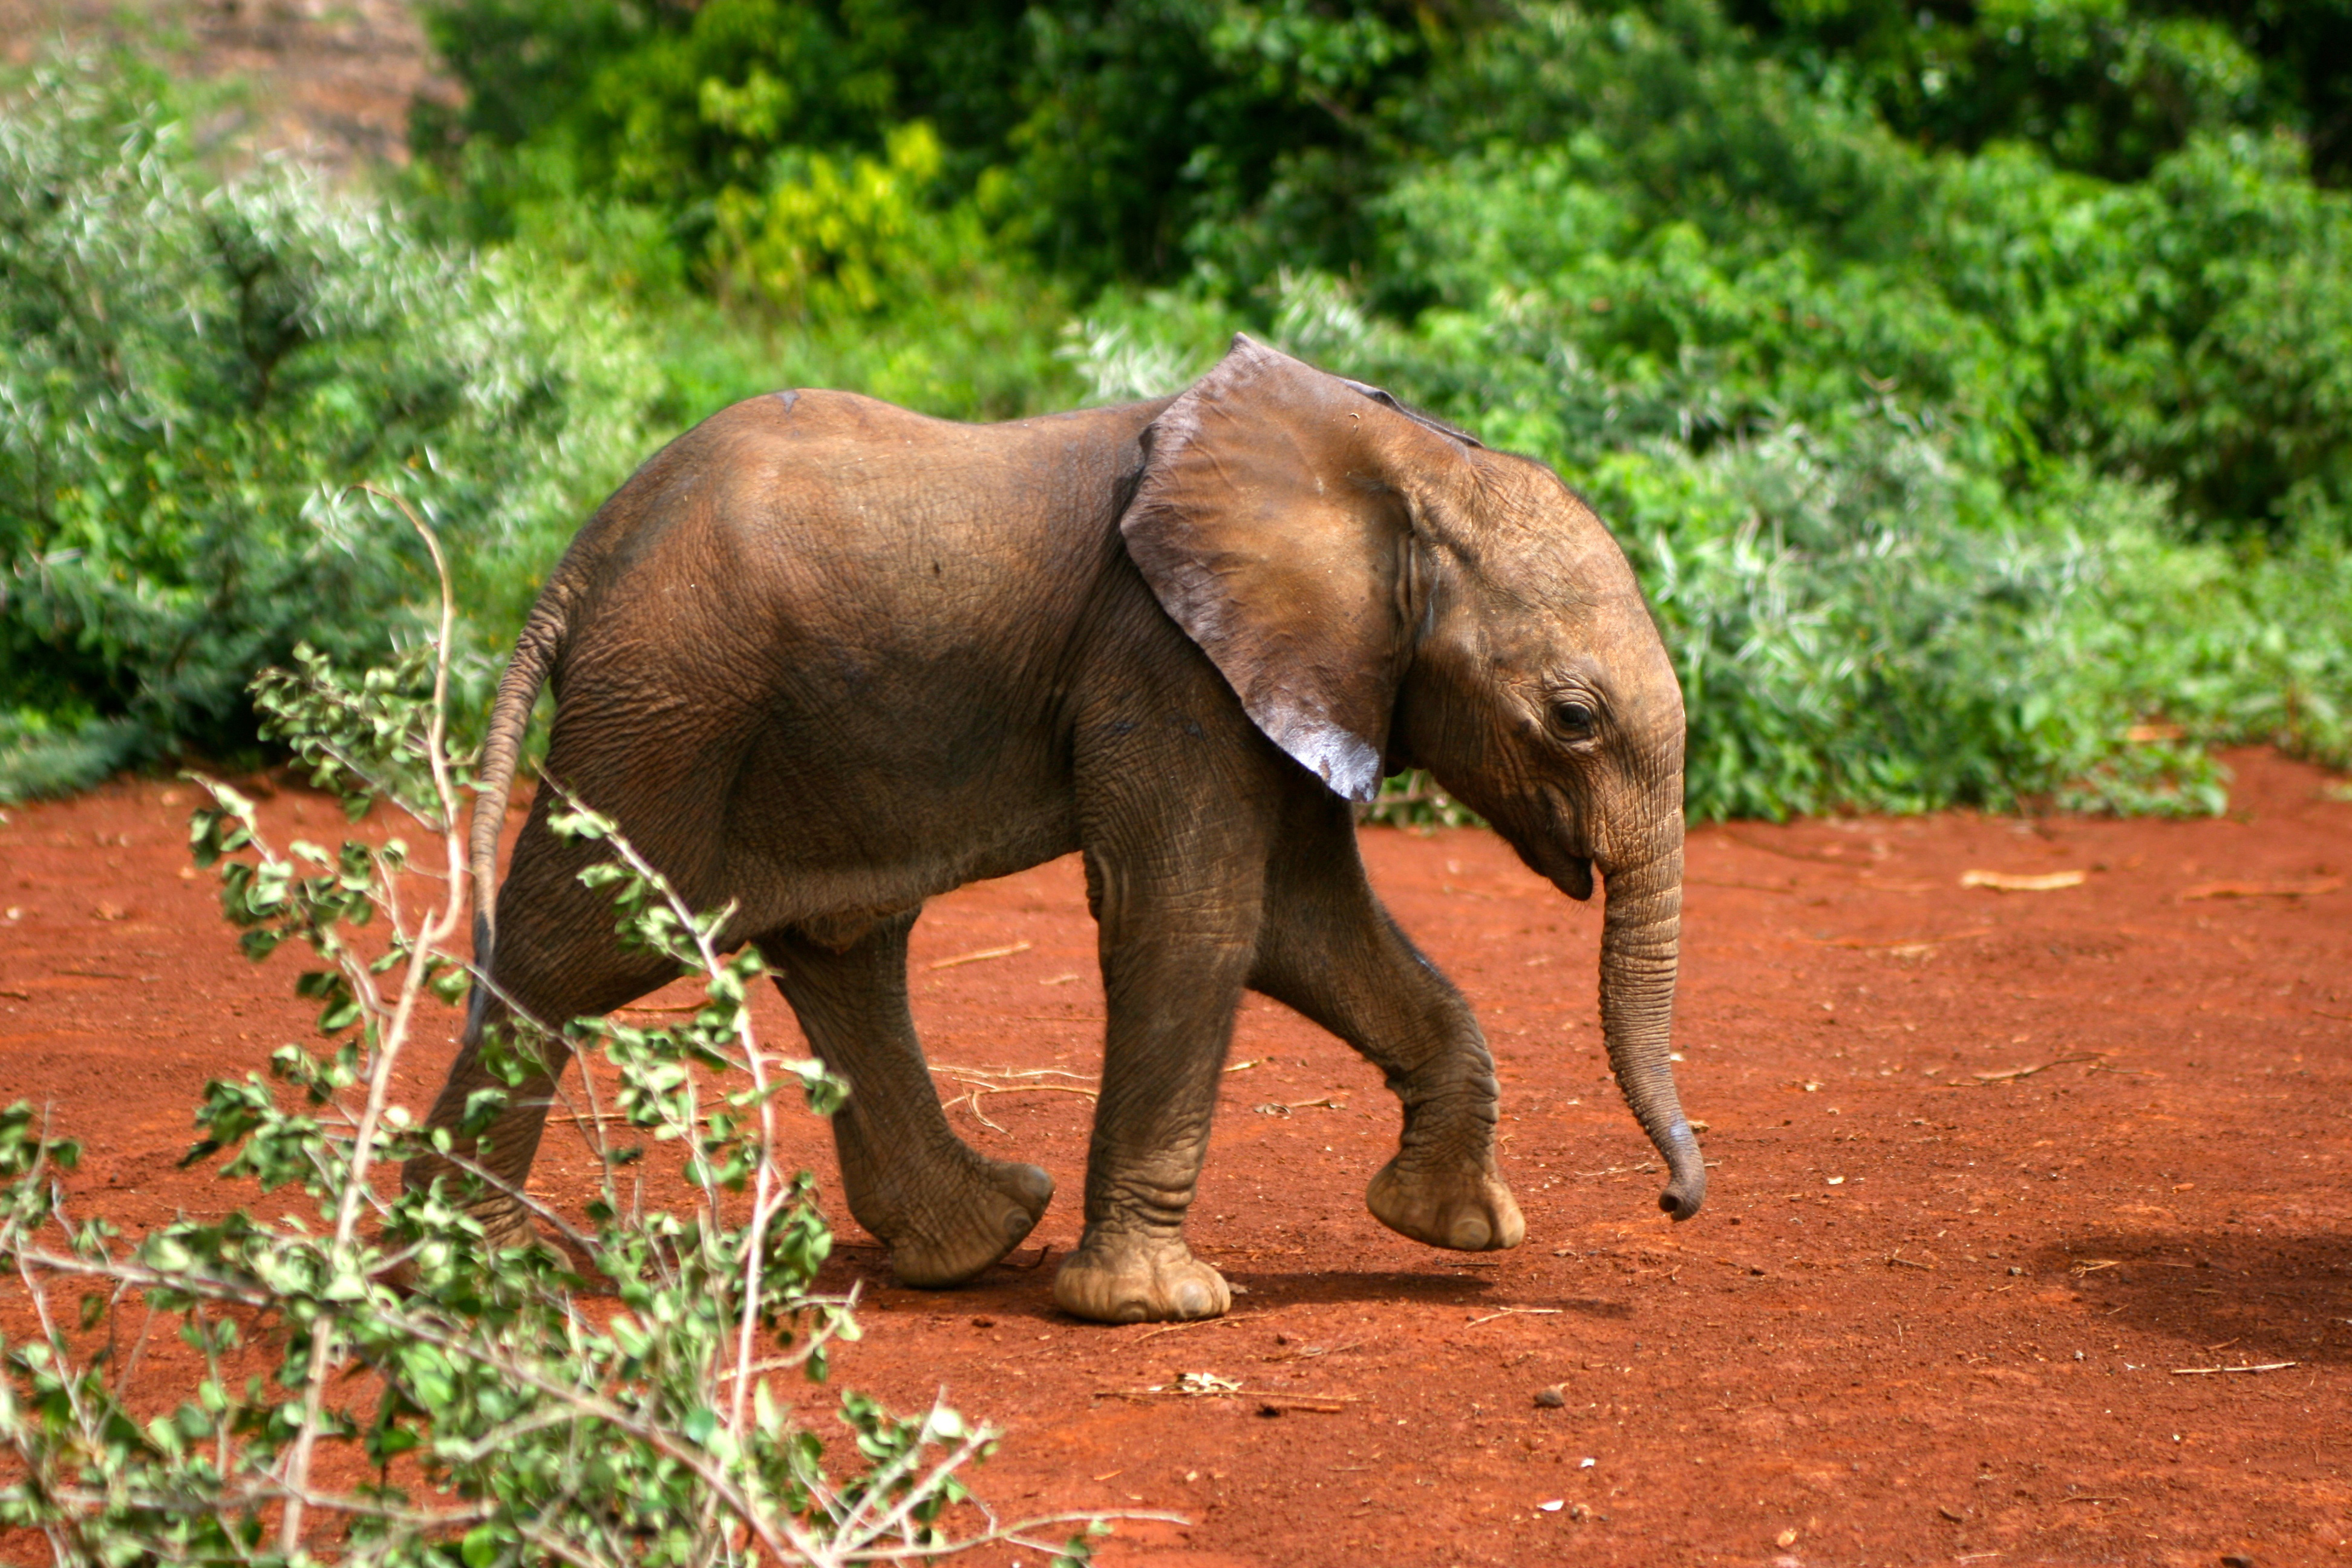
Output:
top-left (1602, 832), bottom-right (1708, 1220)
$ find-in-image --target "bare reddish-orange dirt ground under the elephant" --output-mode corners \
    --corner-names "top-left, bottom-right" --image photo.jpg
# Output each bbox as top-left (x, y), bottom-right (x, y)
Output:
top-left (0, 753), bottom-right (2352, 1568)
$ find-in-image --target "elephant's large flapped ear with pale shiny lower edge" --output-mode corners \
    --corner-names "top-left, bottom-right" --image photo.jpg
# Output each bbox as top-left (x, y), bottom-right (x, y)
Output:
top-left (1120, 336), bottom-right (1475, 799)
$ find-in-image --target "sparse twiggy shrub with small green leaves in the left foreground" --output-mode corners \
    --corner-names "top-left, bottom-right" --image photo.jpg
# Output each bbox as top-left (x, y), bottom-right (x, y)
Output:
top-left (0, 606), bottom-right (1103, 1568)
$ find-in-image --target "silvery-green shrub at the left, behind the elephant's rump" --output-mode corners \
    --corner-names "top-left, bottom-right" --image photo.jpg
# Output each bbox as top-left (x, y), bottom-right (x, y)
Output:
top-left (0, 68), bottom-right (659, 794)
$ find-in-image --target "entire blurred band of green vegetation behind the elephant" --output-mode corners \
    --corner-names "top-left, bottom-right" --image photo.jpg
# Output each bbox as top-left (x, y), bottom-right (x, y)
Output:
top-left (0, 0), bottom-right (2352, 815)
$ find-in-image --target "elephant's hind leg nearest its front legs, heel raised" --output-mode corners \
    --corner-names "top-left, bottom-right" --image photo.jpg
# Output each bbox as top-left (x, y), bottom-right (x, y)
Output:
top-left (757, 915), bottom-right (1054, 1286)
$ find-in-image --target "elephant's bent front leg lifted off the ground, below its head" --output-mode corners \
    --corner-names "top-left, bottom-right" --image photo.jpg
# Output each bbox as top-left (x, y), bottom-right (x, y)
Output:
top-left (1251, 802), bottom-right (1526, 1253)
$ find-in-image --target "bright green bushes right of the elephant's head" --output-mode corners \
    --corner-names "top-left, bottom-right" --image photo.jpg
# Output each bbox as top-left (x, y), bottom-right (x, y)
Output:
top-left (1214, 5), bottom-right (2352, 815)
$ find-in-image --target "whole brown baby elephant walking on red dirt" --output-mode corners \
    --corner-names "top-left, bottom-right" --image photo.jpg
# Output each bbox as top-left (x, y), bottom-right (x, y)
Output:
top-left (407, 339), bottom-right (1705, 1324)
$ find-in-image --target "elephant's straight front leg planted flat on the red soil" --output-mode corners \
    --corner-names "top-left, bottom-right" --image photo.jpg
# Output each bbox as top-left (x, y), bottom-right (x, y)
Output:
top-left (1054, 854), bottom-right (1258, 1324)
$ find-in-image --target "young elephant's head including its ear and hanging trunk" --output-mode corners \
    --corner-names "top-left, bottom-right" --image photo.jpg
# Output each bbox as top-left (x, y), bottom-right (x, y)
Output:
top-left (1120, 336), bottom-right (1708, 1220)
